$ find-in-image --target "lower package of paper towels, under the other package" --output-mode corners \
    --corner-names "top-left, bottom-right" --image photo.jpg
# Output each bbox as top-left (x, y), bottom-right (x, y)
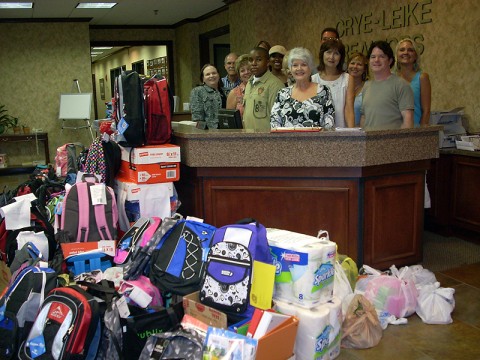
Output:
top-left (274, 297), bottom-right (342, 360)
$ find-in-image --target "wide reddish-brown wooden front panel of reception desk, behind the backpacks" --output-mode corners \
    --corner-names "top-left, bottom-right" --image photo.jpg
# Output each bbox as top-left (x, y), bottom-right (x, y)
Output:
top-left (203, 178), bottom-right (359, 258)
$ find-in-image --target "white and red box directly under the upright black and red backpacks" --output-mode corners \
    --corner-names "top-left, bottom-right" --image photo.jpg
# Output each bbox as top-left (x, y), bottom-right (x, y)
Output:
top-left (120, 144), bottom-right (180, 165)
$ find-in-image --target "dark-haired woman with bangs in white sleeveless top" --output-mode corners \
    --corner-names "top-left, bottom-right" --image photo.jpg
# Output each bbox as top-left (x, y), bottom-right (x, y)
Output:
top-left (312, 40), bottom-right (355, 128)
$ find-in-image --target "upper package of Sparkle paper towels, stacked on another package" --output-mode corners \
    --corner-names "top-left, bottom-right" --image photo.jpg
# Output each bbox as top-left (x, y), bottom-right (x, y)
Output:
top-left (267, 228), bottom-right (336, 308)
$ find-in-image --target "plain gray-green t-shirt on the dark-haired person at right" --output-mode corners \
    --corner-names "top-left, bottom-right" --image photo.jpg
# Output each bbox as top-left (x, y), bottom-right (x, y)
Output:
top-left (361, 74), bottom-right (414, 129)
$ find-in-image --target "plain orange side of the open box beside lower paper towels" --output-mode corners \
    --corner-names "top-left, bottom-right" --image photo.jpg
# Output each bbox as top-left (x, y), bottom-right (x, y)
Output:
top-left (255, 316), bottom-right (298, 360)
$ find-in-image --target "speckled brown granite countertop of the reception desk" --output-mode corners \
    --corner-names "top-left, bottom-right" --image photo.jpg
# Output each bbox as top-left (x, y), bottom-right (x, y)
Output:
top-left (173, 124), bottom-right (442, 167)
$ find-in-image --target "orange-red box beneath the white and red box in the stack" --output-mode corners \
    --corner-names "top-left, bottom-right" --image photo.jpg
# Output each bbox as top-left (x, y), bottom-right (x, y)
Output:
top-left (118, 160), bottom-right (180, 184)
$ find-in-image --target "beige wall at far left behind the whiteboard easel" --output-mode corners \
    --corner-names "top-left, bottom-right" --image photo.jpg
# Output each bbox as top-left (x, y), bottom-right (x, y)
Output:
top-left (0, 22), bottom-right (93, 164)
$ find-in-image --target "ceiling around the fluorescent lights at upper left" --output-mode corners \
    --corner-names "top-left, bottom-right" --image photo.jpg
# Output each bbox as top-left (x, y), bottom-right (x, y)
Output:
top-left (0, 0), bottom-right (228, 26)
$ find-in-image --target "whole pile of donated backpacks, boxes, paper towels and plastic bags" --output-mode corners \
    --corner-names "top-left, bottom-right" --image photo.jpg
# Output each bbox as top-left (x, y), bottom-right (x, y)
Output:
top-left (0, 72), bottom-right (454, 360)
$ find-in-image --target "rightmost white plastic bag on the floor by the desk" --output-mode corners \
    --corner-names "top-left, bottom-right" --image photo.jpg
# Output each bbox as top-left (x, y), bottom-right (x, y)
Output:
top-left (416, 282), bottom-right (455, 324)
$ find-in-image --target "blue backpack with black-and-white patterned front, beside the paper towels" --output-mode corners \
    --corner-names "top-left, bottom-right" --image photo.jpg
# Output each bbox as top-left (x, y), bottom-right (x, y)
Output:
top-left (199, 219), bottom-right (273, 317)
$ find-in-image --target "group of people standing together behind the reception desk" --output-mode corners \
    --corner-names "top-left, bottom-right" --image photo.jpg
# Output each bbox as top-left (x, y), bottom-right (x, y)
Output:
top-left (190, 28), bottom-right (431, 130)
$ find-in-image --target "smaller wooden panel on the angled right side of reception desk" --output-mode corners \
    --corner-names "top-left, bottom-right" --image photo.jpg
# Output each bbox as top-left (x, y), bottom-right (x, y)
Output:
top-left (363, 173), bottom-right (424, 269)
